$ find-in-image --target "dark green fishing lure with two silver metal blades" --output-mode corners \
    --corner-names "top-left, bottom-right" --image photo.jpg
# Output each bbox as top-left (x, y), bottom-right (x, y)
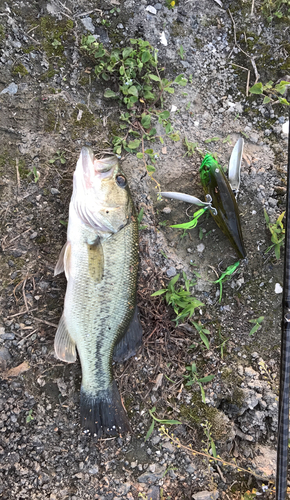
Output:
top-left (161, 138), bottom-right (246, 259)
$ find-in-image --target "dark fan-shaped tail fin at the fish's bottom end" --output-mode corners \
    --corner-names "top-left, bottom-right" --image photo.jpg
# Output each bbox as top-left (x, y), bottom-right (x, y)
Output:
top-left (80, 380), bottom-right (130, 438)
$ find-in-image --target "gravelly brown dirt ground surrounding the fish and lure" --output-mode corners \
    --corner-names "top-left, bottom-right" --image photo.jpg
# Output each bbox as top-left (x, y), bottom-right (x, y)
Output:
top-left (0, 0), bottom-right (290, 500)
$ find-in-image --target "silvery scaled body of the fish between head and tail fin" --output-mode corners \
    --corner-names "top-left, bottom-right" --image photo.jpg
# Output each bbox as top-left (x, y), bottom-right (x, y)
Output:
top-left (65, 222), bottom-right (138, 393)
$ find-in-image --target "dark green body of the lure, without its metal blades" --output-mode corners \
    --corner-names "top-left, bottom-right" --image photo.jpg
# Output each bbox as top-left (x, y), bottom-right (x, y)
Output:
top-left (199, 154), bottom-right (246, 259)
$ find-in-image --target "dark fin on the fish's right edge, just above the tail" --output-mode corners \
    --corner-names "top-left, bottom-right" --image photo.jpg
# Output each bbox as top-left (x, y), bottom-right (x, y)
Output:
top-left (113, 306), bottom-right (142, 363)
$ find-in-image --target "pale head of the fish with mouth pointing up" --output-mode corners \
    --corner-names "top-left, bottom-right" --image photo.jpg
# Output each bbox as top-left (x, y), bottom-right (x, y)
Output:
top-left (72, 147), bottom-right (134, 233)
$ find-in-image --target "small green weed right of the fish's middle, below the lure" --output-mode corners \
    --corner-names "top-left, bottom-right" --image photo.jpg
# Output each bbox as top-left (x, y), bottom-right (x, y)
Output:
top-left (151, 272), bottom-right (204, 325)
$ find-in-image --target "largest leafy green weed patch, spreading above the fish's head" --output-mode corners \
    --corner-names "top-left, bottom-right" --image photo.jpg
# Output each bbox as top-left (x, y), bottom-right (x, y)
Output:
top-left (81, 35), bottom-right (187, 191)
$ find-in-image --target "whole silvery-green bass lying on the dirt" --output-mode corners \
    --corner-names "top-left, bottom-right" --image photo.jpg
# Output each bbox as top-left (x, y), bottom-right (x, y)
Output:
top-left (54, 147), bottom-right (142, 437)
